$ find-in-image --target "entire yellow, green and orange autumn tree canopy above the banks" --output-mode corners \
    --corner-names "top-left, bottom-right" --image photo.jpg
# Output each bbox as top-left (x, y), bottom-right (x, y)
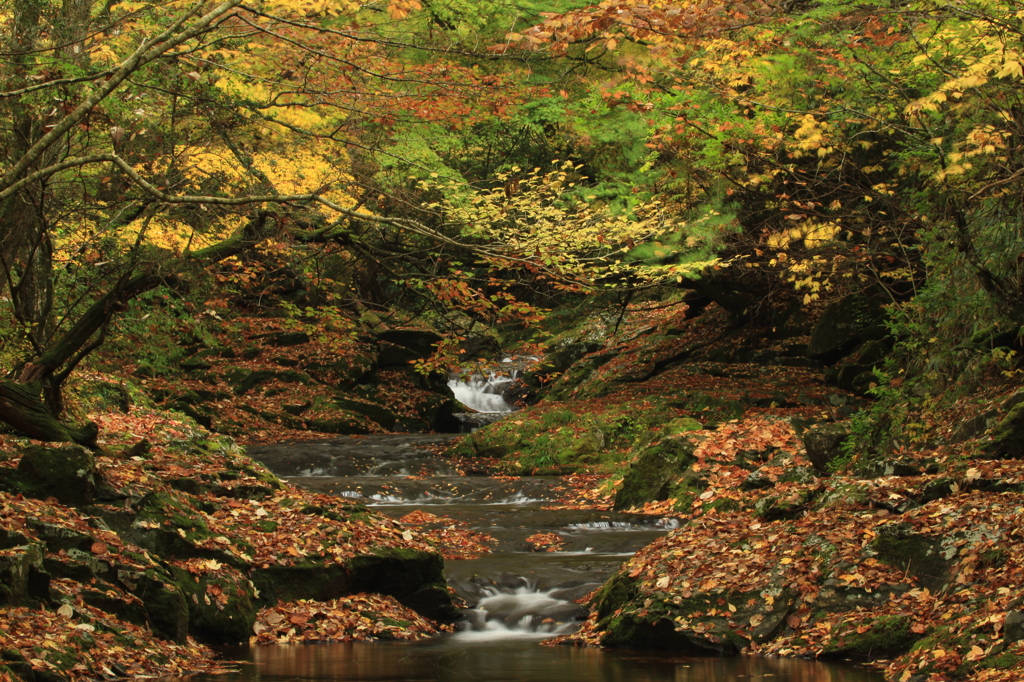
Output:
top-left (0, 0), bottom-right (1024, 442)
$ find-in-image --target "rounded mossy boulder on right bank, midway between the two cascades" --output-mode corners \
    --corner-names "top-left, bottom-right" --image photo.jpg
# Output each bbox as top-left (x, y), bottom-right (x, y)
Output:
top-left (614, 436), bottom-right (699, 510)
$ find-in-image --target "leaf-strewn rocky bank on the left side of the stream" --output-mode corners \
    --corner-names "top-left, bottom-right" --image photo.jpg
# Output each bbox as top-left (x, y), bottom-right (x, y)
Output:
top-left (0, 401), bottom-right (486, 680)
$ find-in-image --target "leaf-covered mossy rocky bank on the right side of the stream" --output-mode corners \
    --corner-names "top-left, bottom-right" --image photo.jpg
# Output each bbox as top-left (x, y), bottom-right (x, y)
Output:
top-left (456, 301), bottom-right (1024, 682)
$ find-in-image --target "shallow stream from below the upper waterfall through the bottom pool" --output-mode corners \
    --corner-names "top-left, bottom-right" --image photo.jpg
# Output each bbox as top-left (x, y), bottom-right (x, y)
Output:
top-left (180, 434), bottom-right (883, 682)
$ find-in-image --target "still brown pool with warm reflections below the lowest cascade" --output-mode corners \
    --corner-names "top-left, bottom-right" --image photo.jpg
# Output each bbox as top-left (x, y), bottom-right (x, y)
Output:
top-left (180, 640), bottom-right (883, 682)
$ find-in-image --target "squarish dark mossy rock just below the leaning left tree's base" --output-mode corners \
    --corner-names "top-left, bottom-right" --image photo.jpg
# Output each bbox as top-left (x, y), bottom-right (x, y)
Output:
top-left (17, 444), bottom-right (96, 505)
